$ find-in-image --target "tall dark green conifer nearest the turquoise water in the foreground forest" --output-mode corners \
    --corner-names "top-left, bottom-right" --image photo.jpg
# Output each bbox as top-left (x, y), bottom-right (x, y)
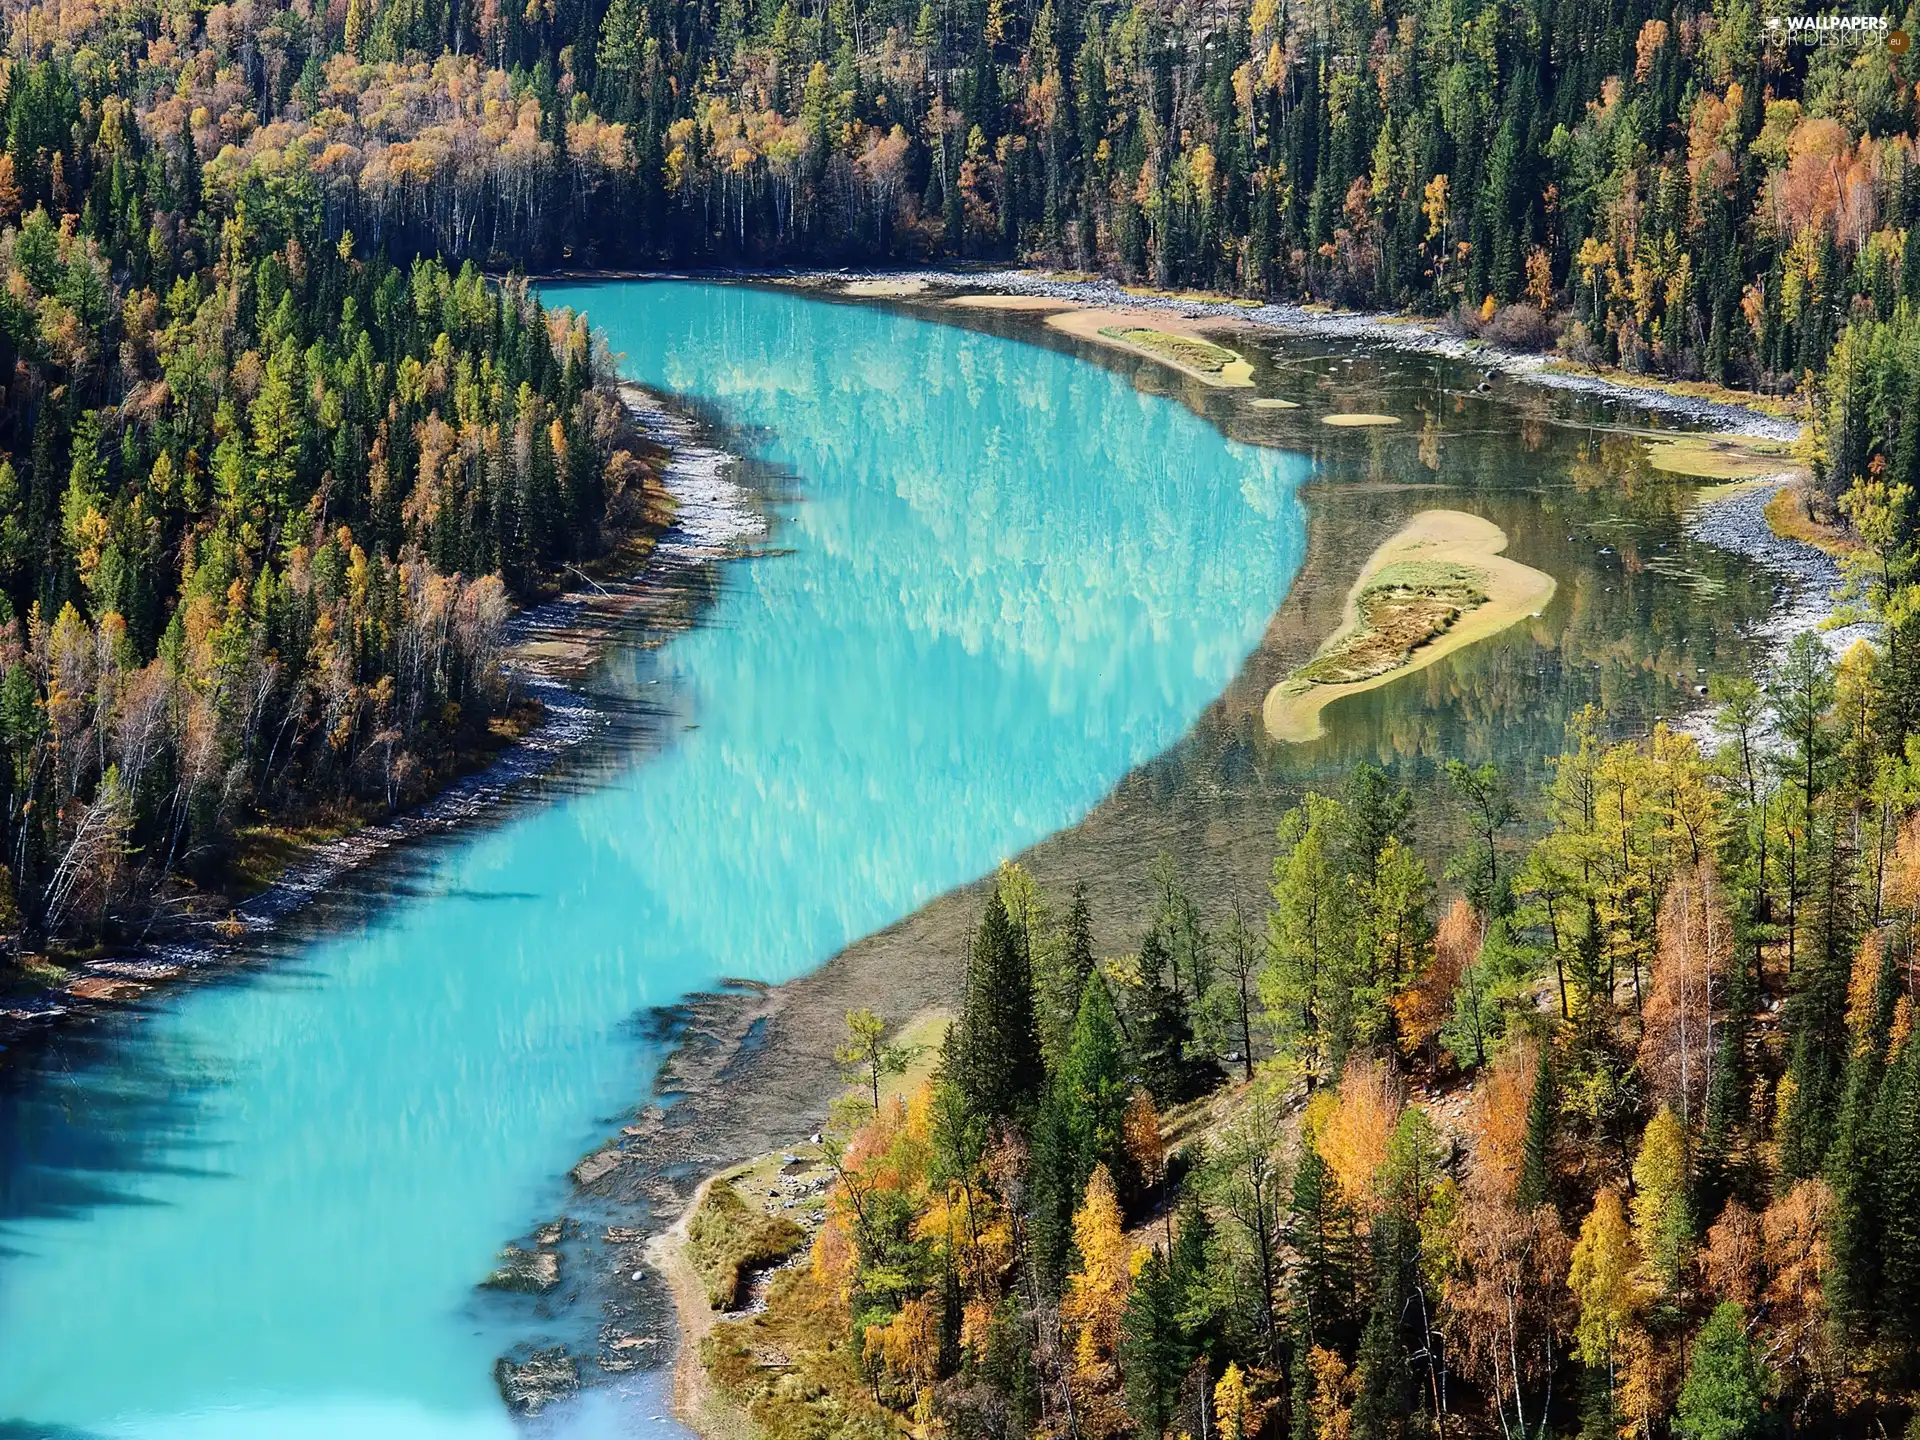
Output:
top-left (947, 893), bottom-right (1044, 1123)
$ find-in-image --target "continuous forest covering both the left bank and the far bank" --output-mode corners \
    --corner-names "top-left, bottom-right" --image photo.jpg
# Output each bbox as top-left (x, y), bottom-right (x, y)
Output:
top-left (0, 0), bottom-right (1920, 952)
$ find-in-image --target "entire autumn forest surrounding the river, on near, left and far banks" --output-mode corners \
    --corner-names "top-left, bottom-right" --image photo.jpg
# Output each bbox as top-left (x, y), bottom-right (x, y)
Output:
top-left (0, 0), bottom-right (1920, 1440)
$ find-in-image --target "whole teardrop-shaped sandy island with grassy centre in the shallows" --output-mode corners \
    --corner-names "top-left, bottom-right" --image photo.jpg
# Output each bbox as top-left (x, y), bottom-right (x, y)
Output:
top-left (1261, 511), bottom-right (1555, 741)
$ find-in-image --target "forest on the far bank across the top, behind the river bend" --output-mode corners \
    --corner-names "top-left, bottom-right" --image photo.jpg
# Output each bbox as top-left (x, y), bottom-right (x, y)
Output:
top-left (15, 0), bottom-right (1920, 394)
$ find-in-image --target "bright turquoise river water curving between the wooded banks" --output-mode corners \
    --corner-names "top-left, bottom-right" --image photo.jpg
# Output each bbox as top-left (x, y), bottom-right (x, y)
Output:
top-left (0, 284), bottom-right (1309, 1440)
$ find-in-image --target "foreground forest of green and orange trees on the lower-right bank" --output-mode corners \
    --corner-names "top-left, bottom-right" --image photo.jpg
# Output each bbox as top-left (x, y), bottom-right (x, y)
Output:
top-left (703, 522), bottom-right (1920, 1440)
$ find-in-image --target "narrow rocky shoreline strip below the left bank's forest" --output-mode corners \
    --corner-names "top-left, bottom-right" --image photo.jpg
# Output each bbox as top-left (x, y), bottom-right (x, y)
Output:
top-left (0, 380), bottom-right (756, 1064)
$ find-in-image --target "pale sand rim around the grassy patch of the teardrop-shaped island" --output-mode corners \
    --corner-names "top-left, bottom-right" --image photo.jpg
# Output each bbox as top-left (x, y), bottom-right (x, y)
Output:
top-left (1261, 511), bottom-right (1557, 741)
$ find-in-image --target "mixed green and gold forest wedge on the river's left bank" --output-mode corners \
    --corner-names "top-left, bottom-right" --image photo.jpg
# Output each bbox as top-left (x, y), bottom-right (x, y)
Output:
top-left (0, 10), bottom-right (660, 954)
